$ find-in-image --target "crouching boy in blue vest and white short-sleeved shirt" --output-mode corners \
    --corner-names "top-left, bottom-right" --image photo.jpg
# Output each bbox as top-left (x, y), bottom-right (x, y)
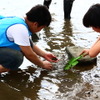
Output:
top-left (0, 5), bottom-right (58, 73)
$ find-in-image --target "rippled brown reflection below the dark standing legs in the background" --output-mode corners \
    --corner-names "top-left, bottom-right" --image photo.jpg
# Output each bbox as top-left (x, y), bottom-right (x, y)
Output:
top-left (44, 20), bottom-right (74, 52)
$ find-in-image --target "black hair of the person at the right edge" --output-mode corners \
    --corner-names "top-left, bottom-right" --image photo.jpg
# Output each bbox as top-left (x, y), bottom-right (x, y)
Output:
top-left (83, 4), bottom-right (100, 27)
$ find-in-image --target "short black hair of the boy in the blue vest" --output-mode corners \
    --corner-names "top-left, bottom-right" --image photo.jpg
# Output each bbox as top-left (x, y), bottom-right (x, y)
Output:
top-left (26, 5), bottom-right (51, 26)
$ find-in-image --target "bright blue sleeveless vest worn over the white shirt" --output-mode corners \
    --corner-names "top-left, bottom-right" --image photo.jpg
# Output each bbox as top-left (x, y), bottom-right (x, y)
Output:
top-left (0, 16), bottom-right (31, 50)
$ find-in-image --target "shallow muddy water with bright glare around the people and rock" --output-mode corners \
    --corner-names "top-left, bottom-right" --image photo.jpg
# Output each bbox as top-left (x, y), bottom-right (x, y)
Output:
top-left (0, 0), bottom-right (100, 100)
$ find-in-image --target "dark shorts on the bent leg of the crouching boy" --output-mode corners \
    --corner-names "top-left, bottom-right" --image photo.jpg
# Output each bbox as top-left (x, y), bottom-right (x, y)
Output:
top-left (0, 48), bottom-right (23, 70)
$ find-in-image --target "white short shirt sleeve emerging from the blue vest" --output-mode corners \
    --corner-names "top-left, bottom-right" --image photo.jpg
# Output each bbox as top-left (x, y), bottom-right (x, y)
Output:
top-left (7, 24), bottom-right (30, 46)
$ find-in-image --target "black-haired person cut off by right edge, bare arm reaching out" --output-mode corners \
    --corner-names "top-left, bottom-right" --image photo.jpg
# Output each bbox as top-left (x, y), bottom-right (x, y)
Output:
top-left (81, 4), bottom-right (100, 57)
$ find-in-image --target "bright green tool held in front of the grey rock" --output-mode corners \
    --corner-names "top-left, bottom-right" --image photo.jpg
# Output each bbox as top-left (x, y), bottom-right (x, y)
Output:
top-left (64, 55), bottom-right (83, 70)
